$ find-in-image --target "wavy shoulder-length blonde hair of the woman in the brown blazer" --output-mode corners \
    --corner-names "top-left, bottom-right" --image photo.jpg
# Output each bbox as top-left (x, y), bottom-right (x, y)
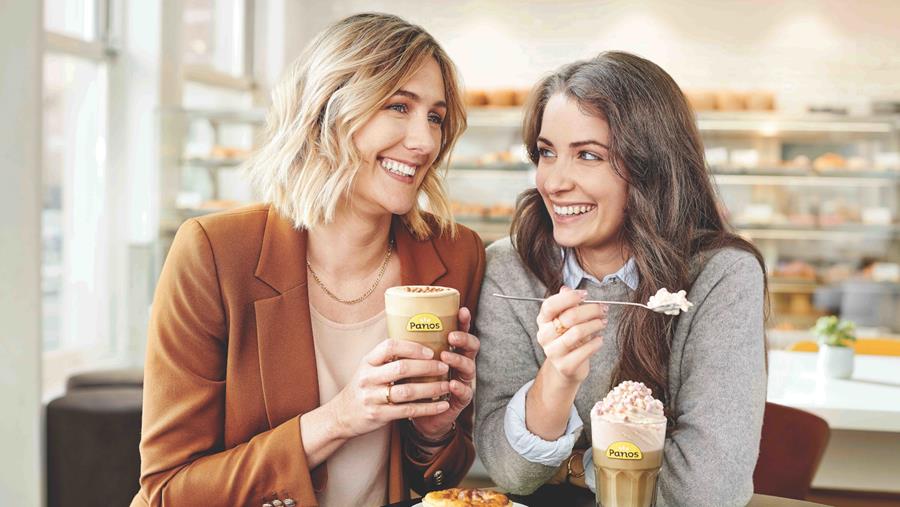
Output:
top-left (245, 13), bottom-right (466, 239)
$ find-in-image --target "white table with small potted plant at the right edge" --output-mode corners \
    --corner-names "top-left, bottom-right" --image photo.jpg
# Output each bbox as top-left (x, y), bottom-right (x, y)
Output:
top-left (767, 350), bottom-right (900, 493)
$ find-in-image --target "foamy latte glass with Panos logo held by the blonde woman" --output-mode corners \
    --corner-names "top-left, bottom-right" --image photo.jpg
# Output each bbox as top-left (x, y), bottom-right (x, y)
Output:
top-left (384, 285), bottom-right (459, 388)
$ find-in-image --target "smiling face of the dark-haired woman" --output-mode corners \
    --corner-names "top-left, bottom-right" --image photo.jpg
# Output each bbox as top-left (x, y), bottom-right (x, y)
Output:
top-left (537, 93), bottom-right (628, 255)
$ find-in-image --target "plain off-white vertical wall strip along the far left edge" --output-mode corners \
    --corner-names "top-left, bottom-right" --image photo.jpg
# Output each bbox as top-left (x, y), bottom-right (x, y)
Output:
top-left (0, 0), bottom-right (44, 506)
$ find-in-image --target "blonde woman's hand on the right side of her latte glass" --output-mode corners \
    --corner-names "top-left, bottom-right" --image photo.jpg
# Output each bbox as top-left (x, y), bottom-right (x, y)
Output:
top-left (412, 307), bottom-right (481, 440)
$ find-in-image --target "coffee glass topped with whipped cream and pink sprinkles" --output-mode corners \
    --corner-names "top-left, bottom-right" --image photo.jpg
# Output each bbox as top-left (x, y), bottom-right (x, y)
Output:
top-left (591, 380), bottom-right (667, 507)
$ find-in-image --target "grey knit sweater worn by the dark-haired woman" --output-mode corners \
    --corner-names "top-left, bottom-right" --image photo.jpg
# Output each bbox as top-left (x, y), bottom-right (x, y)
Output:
top-left (475, 238), bottom-right (766, 507)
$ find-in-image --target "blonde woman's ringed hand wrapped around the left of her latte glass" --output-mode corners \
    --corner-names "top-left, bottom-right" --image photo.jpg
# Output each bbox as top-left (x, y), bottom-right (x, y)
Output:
top-left (329, 340), bottom-right (455, 439)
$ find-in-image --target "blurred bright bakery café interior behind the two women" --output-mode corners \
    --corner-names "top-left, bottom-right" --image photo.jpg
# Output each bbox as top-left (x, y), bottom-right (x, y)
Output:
top-left (0, 0), bottom-right (900, 505)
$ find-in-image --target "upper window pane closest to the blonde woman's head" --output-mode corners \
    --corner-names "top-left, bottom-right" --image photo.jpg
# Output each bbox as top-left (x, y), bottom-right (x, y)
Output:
top-left (184, 0), bottom-right (244, 76)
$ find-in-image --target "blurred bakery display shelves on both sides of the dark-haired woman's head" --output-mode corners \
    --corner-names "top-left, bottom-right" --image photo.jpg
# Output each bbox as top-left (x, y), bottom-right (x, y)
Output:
top-left (448, 105), bottom-right (900, 332)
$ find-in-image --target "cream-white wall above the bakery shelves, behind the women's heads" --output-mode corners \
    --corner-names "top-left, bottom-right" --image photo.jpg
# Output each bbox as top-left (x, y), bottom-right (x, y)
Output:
top-left (270, 0), bottom-right (900, 113)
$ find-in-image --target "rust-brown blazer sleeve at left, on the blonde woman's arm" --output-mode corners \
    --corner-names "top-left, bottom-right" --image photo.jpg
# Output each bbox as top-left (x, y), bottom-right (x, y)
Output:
top-left (138, 220), bottom-right (316, 507)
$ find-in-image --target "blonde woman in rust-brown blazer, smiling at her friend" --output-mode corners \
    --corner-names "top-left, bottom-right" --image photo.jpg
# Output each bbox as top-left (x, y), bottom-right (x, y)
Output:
top-left (132, 14), bottom-right (484, 506)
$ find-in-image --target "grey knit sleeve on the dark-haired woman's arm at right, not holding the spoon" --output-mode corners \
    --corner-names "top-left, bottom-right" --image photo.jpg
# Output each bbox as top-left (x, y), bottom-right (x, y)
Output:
top-left (658, 253), bottom-right (766, 507)
